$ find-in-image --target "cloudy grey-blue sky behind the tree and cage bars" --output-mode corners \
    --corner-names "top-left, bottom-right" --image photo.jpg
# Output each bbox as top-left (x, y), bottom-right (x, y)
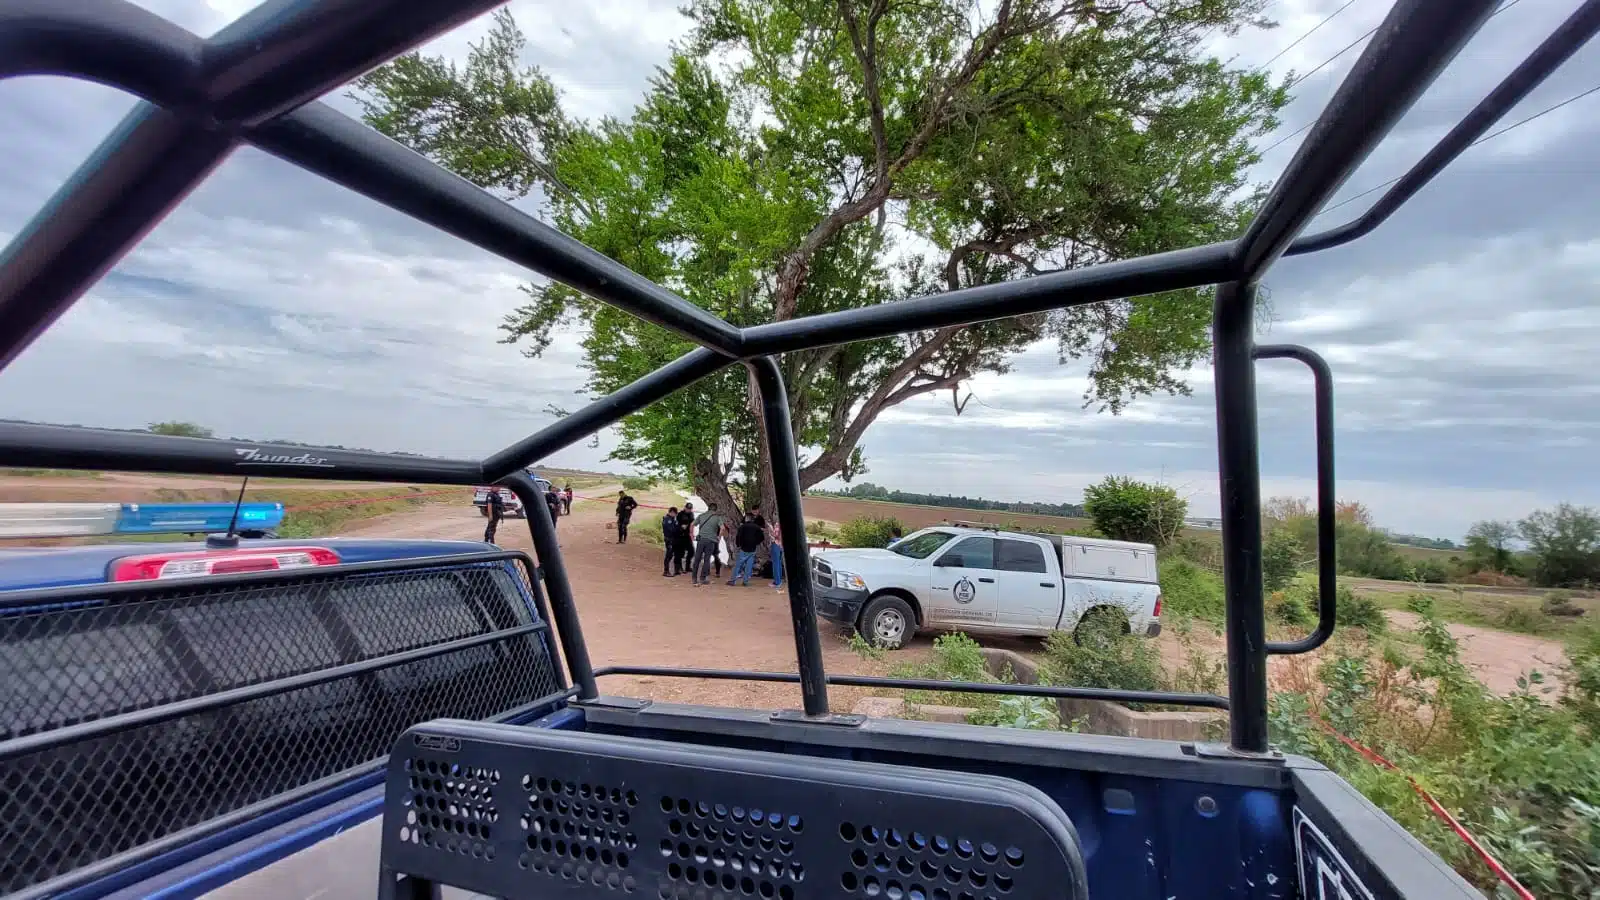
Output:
top-left (0, 0), bottom-right (1600, 538)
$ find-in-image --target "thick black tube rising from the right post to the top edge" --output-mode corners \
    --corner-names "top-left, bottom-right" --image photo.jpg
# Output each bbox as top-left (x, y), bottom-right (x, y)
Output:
top-left (1234, 0), bottom-right (1499, 282)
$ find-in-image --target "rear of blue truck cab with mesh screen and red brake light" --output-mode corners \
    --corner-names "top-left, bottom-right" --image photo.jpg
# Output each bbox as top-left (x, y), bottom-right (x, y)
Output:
top-left (0, 540), bottom-right (565, 898)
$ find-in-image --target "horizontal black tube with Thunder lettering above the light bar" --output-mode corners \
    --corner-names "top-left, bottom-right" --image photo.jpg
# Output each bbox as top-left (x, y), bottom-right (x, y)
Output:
top-left (0, 422), bottom-right (483, 485)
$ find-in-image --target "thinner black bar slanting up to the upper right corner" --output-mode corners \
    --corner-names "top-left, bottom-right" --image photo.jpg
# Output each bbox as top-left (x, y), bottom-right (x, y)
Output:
top-left (1285, 0), bottom-right (1600, 256)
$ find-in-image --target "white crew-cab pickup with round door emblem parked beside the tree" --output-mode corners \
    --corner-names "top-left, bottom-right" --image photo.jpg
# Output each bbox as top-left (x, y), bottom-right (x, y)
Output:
top-left (811, 525), bottom-right (1162, 650)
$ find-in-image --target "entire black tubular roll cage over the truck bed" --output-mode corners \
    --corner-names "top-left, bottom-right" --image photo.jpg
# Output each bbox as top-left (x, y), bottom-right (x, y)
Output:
top-left (0, 0), bottom-right (1600, 756)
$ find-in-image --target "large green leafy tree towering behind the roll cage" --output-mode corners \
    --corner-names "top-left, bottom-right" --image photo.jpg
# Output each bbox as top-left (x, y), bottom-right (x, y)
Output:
top-left (355, 0), bottom-right (1285, 503)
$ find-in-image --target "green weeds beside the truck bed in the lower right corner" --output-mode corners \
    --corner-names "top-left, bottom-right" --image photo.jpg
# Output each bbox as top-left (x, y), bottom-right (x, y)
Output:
top-left (1270, 596), bottom-right (1600, 900)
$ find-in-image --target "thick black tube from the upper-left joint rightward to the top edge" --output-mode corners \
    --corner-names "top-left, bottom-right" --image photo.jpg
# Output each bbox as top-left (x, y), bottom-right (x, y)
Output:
top-left (202, 0), bottom-right (502, 125)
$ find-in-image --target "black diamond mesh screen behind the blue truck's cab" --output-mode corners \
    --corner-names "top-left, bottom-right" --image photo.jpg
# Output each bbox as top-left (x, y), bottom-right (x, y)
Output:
top-left (0, 564), bottom-right (558, 894)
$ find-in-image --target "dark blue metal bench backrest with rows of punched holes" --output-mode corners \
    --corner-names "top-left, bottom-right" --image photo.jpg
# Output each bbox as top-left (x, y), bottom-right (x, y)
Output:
top-left (382, 721), bottom-right (1088, 900)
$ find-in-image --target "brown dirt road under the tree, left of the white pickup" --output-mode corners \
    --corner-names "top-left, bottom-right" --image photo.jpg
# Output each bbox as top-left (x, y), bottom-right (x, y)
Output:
top-left (346, 485), bottom-right (902, 713)
